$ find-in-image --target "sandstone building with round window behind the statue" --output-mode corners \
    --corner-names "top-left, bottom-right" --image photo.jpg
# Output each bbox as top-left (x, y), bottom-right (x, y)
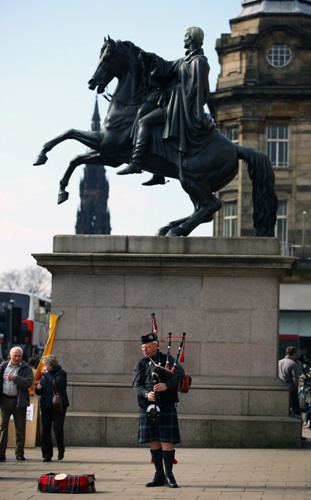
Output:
top-left (213, 0), bottom-right (311, 358)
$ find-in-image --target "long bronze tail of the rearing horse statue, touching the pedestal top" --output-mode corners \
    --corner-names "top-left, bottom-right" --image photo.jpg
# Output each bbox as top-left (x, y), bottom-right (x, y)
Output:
top-left (236, 145), bottom-right (278, 236)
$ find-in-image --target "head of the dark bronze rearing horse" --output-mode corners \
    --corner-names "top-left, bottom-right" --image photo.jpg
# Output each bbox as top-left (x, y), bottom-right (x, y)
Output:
top-left (88, 36), bottom-right (119, 94)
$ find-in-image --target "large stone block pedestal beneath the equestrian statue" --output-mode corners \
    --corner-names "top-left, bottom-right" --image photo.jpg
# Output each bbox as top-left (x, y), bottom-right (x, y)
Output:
top-left (34, 235), bottom-right (301, 448)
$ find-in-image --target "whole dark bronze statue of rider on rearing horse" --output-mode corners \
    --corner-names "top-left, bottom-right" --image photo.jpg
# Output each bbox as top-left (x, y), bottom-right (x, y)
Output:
top-left (34, 27), bottom-right (277, 236)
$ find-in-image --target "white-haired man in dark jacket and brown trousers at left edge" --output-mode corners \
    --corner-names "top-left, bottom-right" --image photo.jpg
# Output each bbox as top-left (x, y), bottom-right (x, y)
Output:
top-left (0, 346), bottom-right (34, 462)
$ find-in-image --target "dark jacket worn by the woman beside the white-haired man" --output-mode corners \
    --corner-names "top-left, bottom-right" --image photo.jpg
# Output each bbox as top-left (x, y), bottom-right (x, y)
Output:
top-left (35, 365), bottom-right (69, 410)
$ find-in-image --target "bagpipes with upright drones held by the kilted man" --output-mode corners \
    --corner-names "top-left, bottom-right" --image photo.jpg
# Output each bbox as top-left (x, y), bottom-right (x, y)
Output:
top-left (150, 313), bottom-right (192, 393)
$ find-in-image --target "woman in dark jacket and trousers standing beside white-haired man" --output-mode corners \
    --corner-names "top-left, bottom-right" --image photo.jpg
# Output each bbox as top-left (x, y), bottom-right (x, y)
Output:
top-left (35, 355), bottom-right (69, 462)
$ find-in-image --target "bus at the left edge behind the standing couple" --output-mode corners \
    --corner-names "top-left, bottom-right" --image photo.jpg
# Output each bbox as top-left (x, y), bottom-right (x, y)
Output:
top-left (0, 290), bottom-right (51, 360)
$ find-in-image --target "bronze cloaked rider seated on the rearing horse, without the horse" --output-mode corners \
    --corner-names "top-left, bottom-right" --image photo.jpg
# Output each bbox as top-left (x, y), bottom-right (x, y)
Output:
top-left (118, 27), bottom-right (214, 185)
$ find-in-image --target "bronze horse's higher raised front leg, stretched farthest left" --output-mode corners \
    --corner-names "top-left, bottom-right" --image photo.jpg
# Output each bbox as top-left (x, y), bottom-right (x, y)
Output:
top-left (33, 128), bottom-right (103, 165)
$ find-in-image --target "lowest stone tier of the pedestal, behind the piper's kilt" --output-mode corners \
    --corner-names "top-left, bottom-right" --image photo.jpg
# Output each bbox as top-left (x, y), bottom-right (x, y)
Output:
top-left (65, 412), bottom-right (301, 448)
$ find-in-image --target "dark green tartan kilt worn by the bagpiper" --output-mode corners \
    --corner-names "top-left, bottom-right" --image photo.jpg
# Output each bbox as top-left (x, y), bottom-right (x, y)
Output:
top-left (137, 403), bottom-right (180, 444)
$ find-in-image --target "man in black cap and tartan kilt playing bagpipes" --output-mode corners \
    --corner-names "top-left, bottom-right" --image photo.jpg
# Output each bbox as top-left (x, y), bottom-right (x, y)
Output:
top-left (133, 333), bottom-right (185, 488)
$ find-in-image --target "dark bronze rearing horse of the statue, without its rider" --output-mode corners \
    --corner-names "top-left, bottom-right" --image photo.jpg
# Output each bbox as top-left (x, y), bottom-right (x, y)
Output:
top-left (34, 37), bottom-right (277, 236)
